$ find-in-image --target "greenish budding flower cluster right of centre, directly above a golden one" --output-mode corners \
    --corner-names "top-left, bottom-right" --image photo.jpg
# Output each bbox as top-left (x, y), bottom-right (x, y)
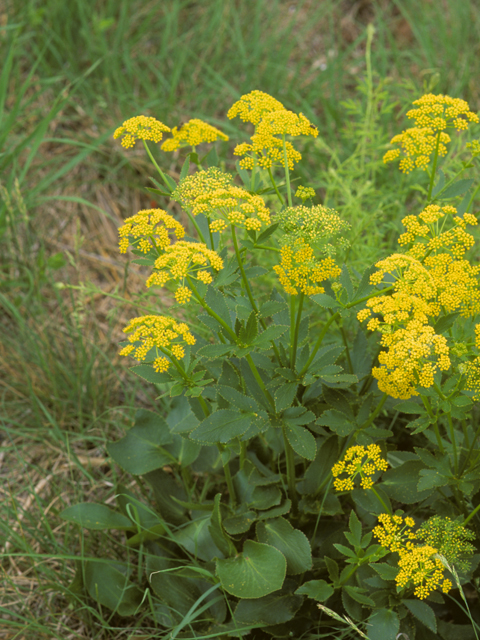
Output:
top-left (275, 205), bottom-right (349, 254)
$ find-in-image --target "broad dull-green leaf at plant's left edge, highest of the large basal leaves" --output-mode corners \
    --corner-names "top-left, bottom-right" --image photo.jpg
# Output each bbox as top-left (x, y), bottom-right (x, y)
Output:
top-left (107, 409), bottom-right (175, 476)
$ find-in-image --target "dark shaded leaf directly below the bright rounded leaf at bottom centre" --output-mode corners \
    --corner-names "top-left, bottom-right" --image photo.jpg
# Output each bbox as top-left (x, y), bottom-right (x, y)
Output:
top-left (235, 592), bottom-right (303, 626)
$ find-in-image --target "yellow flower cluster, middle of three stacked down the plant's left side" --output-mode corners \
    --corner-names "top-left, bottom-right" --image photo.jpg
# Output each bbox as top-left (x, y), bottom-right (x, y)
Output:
top-left (146, 240), bottom-right (223, 304)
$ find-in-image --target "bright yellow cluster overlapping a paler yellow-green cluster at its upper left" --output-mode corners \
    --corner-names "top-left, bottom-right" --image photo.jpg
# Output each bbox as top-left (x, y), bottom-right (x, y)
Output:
top-left (192, 186), bottom-right (270, 232)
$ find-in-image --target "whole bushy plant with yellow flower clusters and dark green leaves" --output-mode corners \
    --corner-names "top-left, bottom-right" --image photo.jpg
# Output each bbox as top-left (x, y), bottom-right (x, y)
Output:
top-left (63, 90), bottom-right (480, 640)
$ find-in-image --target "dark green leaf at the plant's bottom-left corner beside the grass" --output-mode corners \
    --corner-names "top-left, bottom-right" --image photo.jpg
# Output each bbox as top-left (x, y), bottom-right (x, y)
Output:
top-left (84, 560), bottom-right (142, 616)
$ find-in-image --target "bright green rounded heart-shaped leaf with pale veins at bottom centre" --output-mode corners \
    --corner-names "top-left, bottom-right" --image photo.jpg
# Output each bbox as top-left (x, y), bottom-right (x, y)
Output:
top-left (216, 540), bottom-right (287, 598)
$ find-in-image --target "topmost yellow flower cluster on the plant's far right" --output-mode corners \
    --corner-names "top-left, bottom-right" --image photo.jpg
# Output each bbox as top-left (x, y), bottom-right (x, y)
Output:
top-left (383, 93), bottom-right (479, 173)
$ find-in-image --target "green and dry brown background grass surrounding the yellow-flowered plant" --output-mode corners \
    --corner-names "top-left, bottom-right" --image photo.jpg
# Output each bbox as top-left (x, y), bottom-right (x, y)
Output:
top-left (0, 0), bottom-right (480, 640)
